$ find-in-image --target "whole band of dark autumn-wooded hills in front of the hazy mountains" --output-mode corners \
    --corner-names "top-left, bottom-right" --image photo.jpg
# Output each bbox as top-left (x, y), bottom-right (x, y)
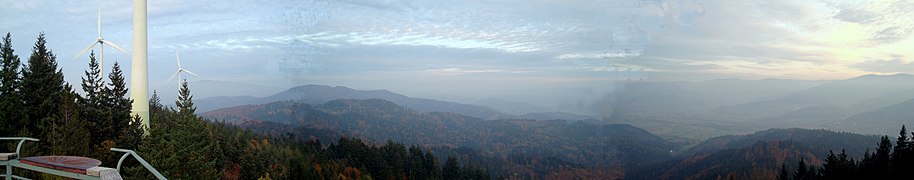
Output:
top-left (204, 96), bottom-right (899, 179)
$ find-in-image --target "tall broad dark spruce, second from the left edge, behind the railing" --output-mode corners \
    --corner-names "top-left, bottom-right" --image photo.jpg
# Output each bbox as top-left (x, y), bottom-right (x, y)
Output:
top-left (20, 33), bottom-right (69, 151)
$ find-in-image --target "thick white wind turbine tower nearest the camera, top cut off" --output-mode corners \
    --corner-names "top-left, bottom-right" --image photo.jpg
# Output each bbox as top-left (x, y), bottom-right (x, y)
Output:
top-left (130, 0), bottom-right (149, 135)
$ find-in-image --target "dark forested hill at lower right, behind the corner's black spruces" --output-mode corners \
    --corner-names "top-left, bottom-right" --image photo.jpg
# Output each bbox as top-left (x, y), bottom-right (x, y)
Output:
top-left (626, 129), bottom-right (879, 179)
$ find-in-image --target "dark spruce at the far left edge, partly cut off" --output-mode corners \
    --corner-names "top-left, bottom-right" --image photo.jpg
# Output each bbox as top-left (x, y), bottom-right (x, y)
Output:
top-left (0, 33), bottom-right (27, 137)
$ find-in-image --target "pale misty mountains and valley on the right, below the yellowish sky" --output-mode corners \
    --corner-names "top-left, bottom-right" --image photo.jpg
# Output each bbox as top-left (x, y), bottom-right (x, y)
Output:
top-left (609, 74), bottom-right (914, 138)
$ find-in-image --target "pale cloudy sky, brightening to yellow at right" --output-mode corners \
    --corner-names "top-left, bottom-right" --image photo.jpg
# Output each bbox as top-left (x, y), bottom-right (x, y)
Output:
top-left (0, 0), bottom-right (914, 110)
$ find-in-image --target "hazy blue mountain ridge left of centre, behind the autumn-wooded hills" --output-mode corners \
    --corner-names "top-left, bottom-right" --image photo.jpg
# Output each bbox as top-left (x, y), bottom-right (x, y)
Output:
top-left (195, 85), bottom-right (591, 120)
